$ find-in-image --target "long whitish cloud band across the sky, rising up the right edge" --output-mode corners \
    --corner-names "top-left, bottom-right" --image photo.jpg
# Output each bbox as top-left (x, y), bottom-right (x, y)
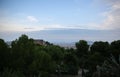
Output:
top-left (0, 0), bottom-right (120, 31)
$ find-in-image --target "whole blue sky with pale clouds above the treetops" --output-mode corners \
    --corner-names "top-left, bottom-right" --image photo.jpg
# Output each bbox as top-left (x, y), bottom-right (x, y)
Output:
top-left (0, 0), bottom-right (120, 42)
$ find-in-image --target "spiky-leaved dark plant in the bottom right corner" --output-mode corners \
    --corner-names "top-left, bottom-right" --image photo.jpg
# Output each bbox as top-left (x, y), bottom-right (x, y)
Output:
top-left (100, 56), bottom-right (120, 77)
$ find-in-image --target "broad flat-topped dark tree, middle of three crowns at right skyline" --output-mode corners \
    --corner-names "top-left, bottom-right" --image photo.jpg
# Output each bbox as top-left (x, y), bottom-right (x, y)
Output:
top-left (85, 41), bottom-right (110, 75)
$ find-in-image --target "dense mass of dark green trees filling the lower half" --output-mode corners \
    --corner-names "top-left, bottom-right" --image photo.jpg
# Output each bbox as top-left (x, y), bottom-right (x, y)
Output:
top-left (0, 35), bottom-right (120, 77)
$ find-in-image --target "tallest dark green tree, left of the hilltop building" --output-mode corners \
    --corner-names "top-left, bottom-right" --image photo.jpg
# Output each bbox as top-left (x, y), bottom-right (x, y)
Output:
top-left (11, 35), bottom-right (34, 73)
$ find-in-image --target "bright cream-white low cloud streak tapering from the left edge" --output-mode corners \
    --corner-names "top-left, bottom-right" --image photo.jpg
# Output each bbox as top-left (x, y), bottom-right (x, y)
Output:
top-left (0, 23), bottom-right (44, 32)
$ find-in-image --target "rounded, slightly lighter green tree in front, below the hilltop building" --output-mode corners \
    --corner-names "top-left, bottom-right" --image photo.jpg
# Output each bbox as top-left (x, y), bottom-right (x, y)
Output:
top-left (28, 50), bottom-right (55, 77)
